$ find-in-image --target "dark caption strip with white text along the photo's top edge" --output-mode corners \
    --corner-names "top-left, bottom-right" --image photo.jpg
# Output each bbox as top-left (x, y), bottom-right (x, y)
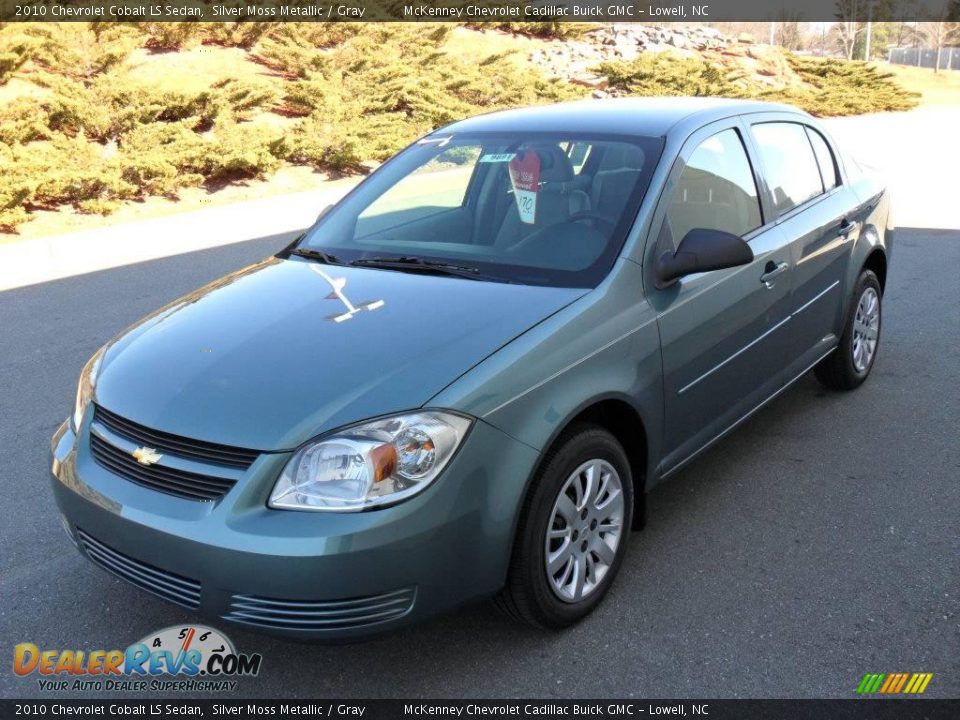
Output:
top-left (0, 0), bottom-right (960, 23)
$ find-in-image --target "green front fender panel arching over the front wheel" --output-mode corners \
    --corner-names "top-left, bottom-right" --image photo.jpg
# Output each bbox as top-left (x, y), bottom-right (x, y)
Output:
top-left (430, 259), bottom-right (663, 490)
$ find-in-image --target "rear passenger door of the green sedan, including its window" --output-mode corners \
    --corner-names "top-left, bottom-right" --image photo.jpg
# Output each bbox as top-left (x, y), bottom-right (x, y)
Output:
top-left (750, 114), bottom-right (861, 379)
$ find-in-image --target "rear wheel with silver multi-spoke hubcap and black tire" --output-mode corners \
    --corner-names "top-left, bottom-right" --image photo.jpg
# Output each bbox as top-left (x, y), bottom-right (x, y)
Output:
top-left (814, 270), bottom-right (883, 390)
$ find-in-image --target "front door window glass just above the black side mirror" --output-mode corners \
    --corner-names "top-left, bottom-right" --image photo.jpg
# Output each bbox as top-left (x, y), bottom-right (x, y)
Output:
top-left (667, 129), bottom-right (763, 247)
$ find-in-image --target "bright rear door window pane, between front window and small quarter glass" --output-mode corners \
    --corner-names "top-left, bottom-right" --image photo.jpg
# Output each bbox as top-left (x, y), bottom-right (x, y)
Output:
top-left (753, 123), bottom-right (823, 213)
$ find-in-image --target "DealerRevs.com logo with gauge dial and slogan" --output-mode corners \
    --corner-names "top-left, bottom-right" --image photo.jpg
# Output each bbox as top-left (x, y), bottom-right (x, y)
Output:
top-left (13, 625), bottom-right (263, 692)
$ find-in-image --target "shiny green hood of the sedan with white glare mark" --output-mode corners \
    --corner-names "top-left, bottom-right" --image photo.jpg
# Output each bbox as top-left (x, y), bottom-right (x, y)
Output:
top-left (96, 258), bottom-right (586, 450)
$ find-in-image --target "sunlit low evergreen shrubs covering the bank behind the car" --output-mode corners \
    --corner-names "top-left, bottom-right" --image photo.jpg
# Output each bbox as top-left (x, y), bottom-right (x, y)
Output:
top-left (0, 23), bottom-right (913, 232)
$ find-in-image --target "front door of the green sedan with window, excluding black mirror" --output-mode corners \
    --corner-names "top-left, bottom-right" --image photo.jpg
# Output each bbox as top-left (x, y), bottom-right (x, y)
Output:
top-left (644, 118), bottom-right (791, 473)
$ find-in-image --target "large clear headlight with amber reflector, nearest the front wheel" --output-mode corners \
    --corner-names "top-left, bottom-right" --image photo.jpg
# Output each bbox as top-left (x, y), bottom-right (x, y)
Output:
top-left (268, 410), bottom-right (472, 511)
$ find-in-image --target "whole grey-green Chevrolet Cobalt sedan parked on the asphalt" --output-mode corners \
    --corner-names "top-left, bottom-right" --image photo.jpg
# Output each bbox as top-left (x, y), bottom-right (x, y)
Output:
top-left (52, 99), bottom-right (892, 639)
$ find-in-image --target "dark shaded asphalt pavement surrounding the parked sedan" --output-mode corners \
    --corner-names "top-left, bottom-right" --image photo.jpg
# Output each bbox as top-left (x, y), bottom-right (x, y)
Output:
top-left (0, 112), bottom-right (960, 698)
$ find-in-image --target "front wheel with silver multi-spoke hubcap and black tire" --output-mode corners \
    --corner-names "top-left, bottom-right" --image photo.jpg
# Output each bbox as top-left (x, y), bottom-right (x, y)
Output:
top-left (496, 425), bottom-right (633, 629)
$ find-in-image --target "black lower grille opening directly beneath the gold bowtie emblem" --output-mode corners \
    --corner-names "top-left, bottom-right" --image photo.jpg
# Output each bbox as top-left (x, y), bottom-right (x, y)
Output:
top-left (90, 433), bottom-right (236, 500)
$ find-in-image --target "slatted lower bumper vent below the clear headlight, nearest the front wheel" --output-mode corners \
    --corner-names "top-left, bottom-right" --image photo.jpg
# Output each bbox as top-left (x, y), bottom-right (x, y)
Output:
top-left (229, 588), bottom-right (417, 631)
